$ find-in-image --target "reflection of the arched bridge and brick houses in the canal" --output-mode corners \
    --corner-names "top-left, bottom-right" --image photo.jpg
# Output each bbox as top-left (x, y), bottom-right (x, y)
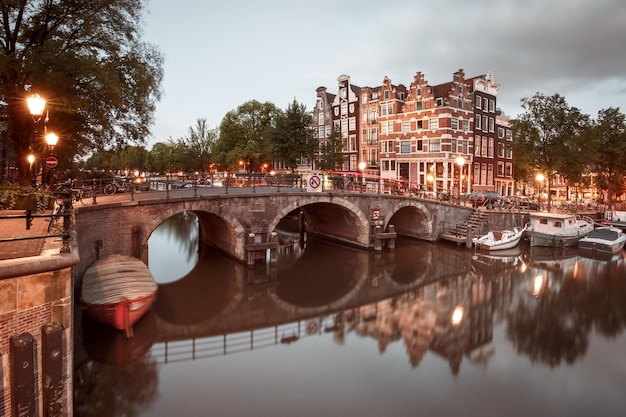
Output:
top-left (107, 242), bottom-right (528, 372)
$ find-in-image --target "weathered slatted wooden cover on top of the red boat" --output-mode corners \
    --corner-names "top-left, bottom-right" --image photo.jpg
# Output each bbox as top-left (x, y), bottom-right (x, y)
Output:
top-left (81, 255), bottom-right (158, 304)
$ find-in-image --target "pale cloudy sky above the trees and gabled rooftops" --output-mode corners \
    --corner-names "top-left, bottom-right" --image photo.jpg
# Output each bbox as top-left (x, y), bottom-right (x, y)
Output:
top-left (144, 0), bottom-right (626, 147)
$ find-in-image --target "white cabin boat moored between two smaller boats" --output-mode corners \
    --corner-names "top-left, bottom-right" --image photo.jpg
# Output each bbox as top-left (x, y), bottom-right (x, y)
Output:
top-left (530, 212), bottom-right (595, 247)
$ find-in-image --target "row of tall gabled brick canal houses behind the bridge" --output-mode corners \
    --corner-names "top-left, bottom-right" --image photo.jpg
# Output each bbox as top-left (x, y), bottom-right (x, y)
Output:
top-left (313, 69), bottom-right (515, 195)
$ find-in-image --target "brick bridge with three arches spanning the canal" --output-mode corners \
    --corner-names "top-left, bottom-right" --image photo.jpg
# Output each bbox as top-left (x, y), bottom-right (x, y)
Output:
top-left (74, 192), bottom-right (471, 285)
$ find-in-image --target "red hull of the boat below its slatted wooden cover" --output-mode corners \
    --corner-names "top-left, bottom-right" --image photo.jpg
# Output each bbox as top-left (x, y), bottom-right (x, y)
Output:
top-left (86, 294), bottom-right (155, 332)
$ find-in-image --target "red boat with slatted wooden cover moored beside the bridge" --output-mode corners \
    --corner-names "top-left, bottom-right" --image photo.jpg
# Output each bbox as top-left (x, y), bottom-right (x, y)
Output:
top-left (81, 255), bottom-right (158, 337)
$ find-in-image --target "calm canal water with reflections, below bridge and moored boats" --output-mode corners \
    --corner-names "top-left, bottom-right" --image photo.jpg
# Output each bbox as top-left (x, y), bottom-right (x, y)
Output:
top-left (73, 215), bottom-right (626, 417)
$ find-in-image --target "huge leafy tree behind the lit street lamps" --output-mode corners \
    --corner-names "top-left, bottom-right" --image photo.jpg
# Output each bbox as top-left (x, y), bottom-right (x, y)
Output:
top-left (0, 0), bottom-right (163, 184)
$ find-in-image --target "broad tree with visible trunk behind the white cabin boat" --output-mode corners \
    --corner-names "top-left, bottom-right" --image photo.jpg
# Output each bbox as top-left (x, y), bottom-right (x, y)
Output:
top-left (511, 93), bottom-right (589, 211)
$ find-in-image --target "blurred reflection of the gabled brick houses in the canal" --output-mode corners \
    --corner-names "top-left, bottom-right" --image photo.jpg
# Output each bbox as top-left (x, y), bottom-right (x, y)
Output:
top-left (348, 274), bottom-right (495, 375)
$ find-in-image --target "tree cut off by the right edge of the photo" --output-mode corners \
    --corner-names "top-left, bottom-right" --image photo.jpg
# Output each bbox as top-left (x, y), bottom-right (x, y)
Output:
top-left (591, 108), bottom-right (626, 210)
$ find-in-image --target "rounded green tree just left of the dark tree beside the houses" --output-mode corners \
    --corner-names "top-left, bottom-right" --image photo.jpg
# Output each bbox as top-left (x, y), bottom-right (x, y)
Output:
top-left (215, 100), bottom-right (280, 169)
